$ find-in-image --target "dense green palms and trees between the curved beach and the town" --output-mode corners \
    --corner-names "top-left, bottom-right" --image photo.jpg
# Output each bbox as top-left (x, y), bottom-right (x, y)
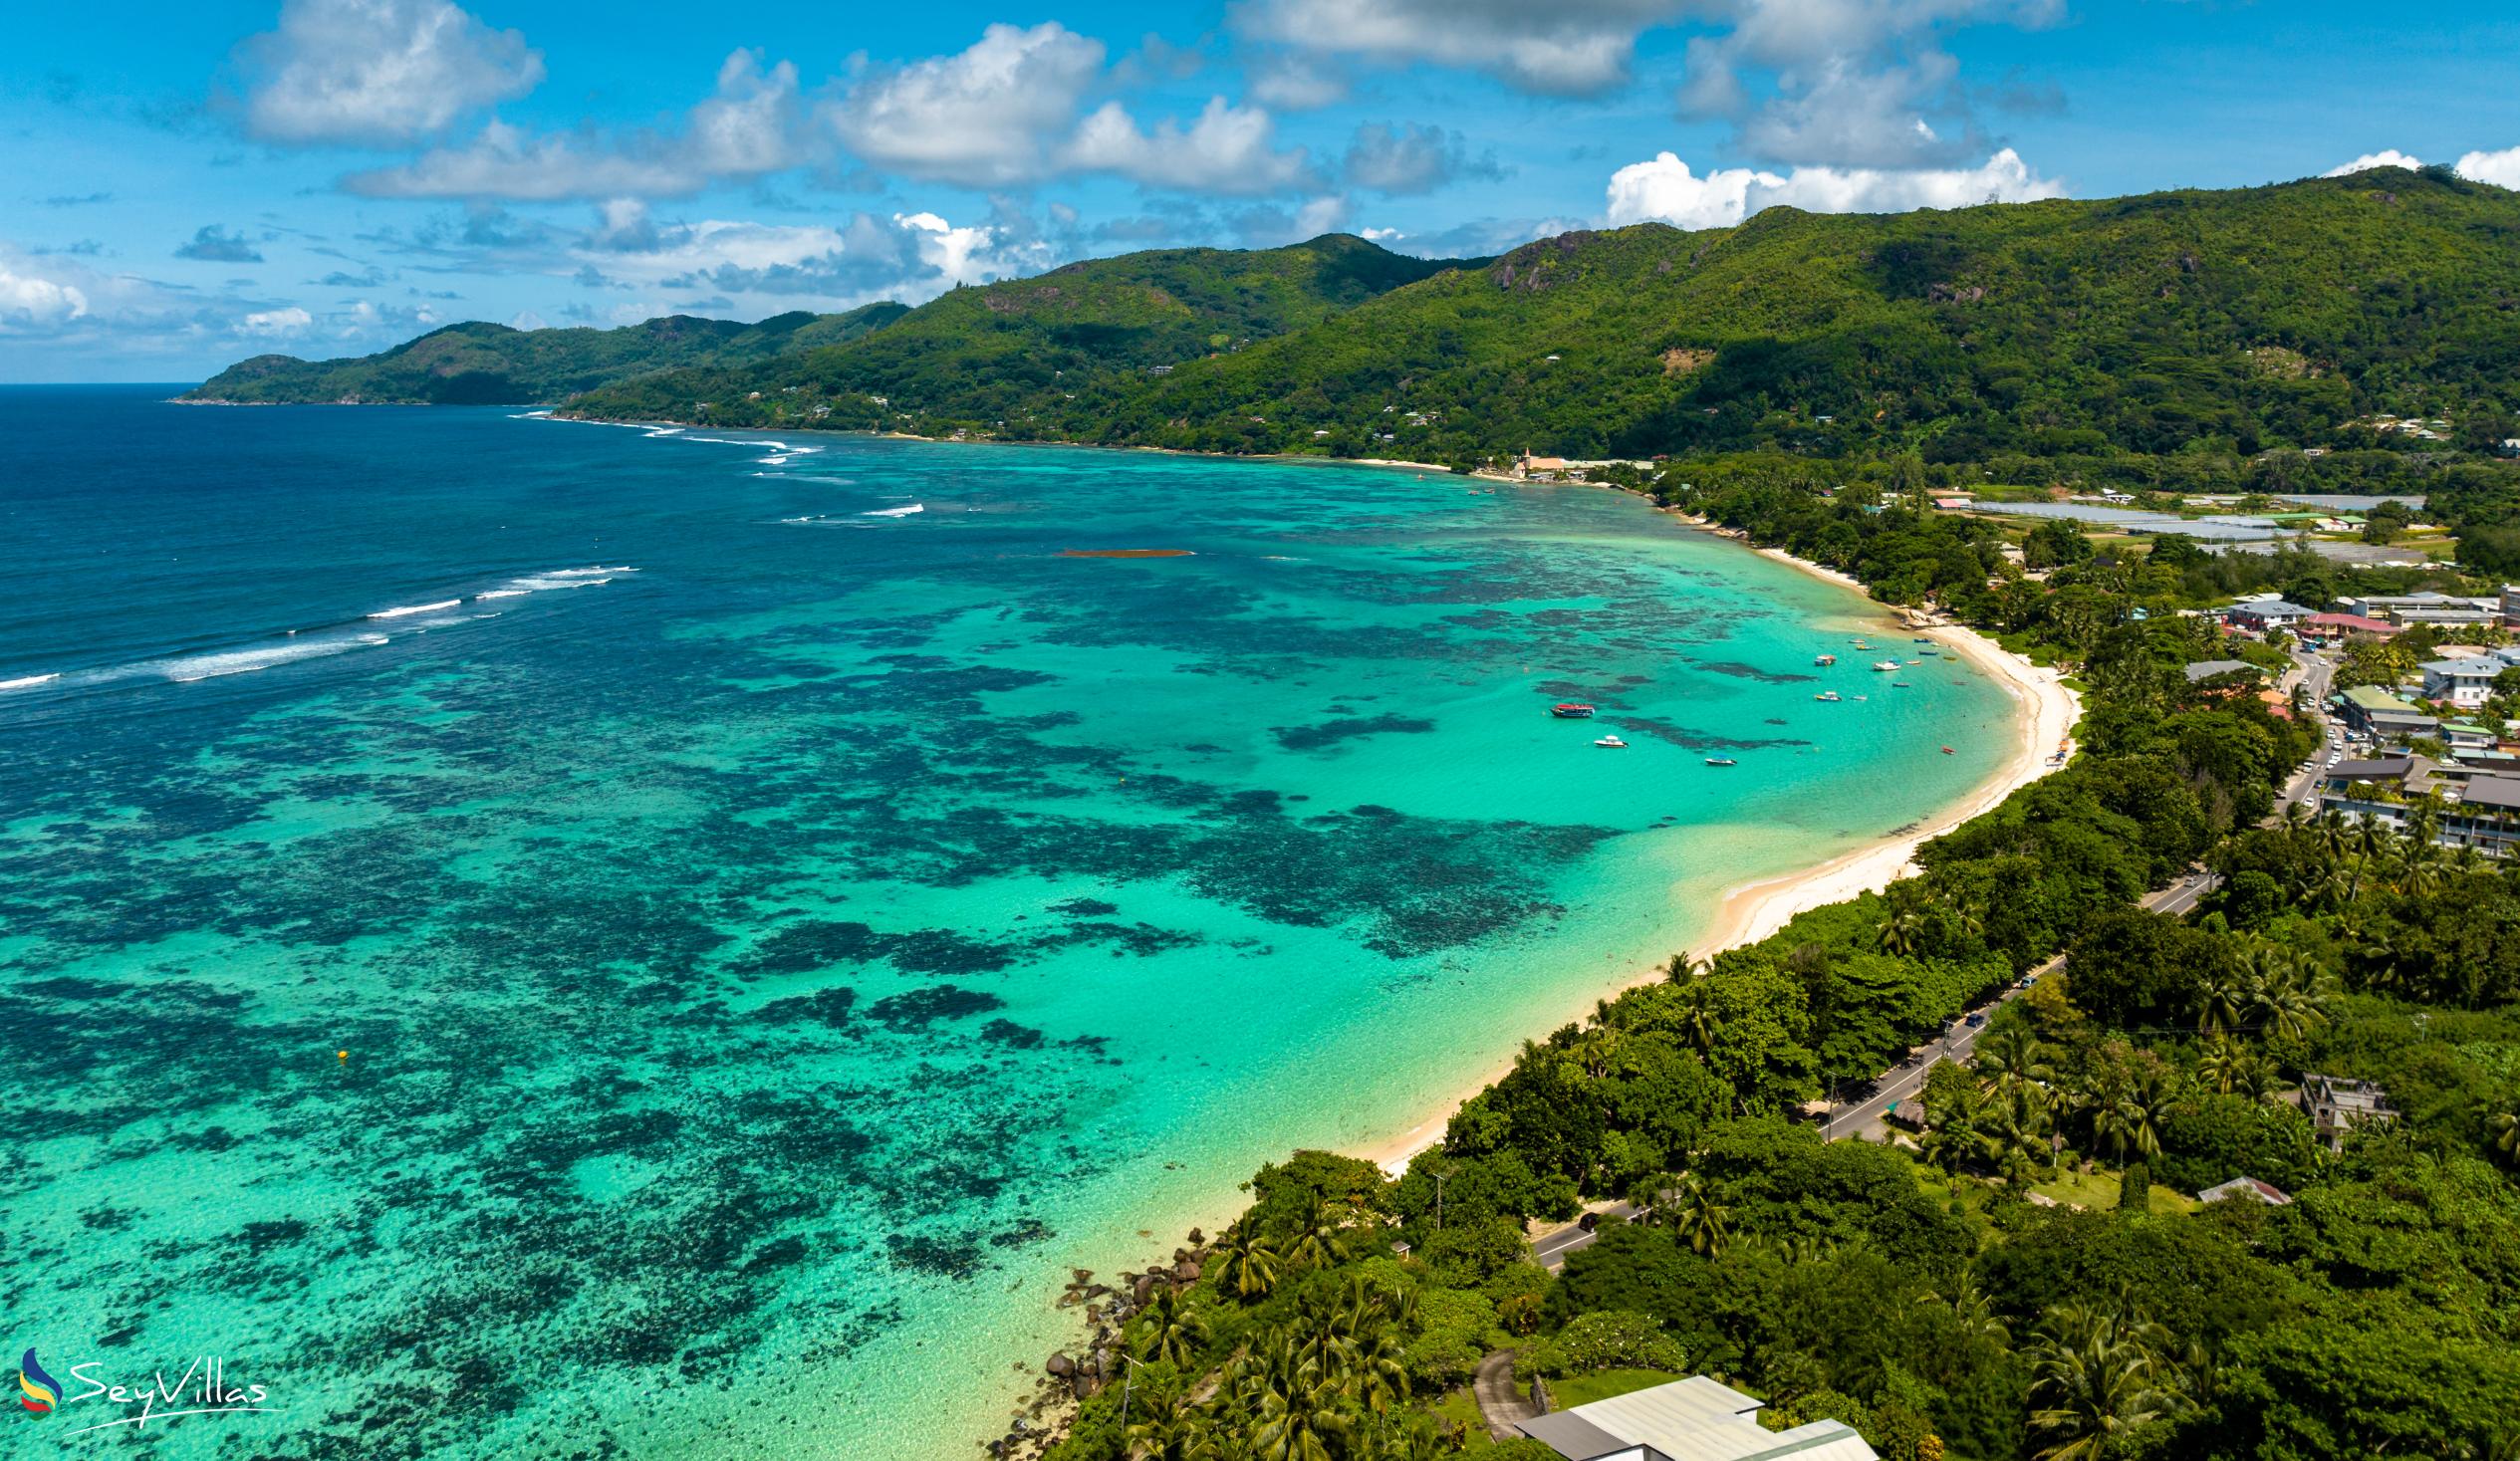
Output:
top-left (1023, 478), bottom-right (2520, 1461)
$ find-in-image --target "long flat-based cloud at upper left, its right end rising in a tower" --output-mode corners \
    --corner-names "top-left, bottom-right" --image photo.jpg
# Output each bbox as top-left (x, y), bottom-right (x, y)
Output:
top-left (343, 51), bottom-right (802, 201)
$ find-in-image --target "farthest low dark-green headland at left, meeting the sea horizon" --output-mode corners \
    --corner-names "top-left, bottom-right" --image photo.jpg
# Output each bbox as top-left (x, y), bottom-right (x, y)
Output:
top-left (184, 303), bottom-right (907, 405)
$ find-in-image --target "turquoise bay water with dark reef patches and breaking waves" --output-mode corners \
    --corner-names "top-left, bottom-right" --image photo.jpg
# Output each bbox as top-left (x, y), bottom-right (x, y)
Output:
top-left (0, 390), bottom-right (2011, 1458)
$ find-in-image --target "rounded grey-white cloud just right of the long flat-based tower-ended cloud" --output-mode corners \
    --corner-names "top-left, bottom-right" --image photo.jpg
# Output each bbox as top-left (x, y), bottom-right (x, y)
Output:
top-left (824, 20), bottom-right (1104, 186)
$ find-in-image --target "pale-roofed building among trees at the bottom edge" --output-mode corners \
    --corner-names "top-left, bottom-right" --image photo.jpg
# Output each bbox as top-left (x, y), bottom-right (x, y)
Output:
top-left (1515, 1375), bottom-right (1880, 1461)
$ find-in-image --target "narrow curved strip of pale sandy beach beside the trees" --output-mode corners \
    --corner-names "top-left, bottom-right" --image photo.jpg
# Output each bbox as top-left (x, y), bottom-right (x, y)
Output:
top-left (1346, 514), bottom-right (2082, 1176)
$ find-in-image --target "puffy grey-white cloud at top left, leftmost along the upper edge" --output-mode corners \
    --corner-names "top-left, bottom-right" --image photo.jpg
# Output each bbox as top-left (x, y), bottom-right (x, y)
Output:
top-left (237, 0), bottom-right (542, 143)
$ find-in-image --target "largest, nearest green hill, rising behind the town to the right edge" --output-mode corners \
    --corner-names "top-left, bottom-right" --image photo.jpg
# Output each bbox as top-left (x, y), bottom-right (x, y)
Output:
top-left (1099, 171), bottom-right (2520, 461)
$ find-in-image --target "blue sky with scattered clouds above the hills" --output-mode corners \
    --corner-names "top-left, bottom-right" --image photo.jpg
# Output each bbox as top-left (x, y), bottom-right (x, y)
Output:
top-left (0, 0), bottom-right (2520, 382)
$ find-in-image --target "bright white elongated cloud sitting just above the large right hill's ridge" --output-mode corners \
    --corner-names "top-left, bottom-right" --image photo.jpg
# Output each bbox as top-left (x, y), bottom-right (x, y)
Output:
top-left (1608, 148), bottom-right (2064, 229)
